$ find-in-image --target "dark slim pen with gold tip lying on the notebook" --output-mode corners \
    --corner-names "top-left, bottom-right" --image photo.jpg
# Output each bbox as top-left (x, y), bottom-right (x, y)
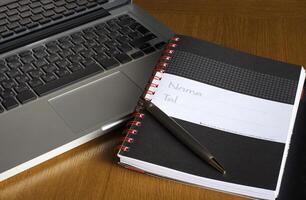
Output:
top-left (143, 100), bottom-right (226, 174)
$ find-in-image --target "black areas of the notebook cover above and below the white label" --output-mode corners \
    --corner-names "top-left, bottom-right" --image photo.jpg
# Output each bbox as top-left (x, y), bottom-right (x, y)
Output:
top-left (119, 35), bottom-right (301, 197)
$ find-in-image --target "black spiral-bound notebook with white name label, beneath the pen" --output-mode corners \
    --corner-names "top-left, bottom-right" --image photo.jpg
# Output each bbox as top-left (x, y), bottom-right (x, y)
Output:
top-left (118, 35), bottom-right (305, 199)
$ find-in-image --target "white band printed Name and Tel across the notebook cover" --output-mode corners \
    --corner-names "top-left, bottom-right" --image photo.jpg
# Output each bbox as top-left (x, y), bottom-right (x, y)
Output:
top-left (152, 73), bottom-right (293, 143)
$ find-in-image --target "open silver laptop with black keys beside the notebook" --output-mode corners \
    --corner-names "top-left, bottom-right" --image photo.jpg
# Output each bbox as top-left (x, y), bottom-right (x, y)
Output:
top-left (0, 0), bottom-right (173, 181)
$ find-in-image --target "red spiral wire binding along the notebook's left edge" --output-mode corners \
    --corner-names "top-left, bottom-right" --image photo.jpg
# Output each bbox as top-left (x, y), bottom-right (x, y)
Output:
top-left (118, 36), bottom-right (180, 152)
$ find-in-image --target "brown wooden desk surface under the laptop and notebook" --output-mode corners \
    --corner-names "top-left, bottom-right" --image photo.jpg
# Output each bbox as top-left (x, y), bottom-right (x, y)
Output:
top-left (0, 0), bottom-right (306, 200)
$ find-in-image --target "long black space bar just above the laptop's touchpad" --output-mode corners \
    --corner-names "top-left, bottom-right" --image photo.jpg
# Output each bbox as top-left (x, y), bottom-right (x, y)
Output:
top-left (34, 64), bottom-right (103, 96)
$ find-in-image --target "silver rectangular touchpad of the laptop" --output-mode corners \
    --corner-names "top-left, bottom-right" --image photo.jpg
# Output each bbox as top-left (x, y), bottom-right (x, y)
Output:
top-left (49, 72), bottom-right (141, 133)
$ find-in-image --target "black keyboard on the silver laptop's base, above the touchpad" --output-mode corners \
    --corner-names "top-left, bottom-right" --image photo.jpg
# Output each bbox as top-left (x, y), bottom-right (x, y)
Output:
top-left (0, 14), bottom-right (165, 113)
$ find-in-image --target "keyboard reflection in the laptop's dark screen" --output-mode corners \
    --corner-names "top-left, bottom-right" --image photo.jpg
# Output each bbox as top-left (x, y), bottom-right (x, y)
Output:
top-left (0, 0), bottom-right (108, 43)
